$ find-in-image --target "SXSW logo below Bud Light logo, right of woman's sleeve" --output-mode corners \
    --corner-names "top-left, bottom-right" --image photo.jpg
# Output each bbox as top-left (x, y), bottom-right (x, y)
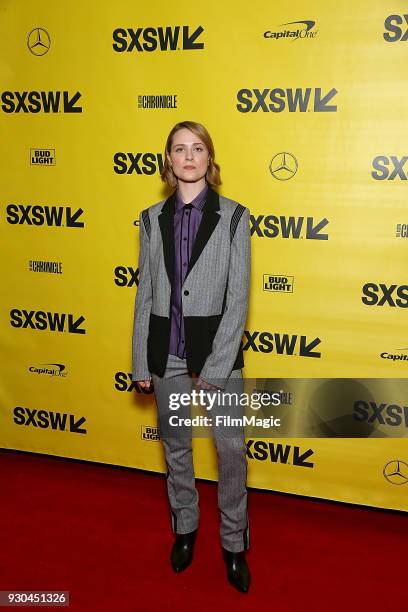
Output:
top-left (244, 330), bottom-right (321, 359)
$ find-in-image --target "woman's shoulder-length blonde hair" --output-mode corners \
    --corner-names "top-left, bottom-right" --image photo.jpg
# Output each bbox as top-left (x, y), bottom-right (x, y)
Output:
top-left (160, 121), bottom-right (221, 188)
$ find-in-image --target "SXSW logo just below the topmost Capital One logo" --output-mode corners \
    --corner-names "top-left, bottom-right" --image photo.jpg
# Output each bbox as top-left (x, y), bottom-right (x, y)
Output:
top-left (236, 87), bottom-right (337, 113)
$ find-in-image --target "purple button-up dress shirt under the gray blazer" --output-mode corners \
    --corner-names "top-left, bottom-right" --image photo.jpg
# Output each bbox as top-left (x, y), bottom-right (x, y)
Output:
top-left (169, 183), bottom-right (208, 359)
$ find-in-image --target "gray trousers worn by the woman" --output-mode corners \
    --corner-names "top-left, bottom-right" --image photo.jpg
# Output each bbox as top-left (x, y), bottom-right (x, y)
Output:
top-left (152, 355), bottom-right (249, 552)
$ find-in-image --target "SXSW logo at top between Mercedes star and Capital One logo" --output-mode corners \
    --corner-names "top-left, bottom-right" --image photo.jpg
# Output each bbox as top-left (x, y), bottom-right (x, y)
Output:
top-left (112, 25), bottom-right (204, 53)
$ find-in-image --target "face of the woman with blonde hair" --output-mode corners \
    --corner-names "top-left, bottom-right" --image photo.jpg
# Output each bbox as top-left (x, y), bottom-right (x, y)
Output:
top-left (167, 128), bottom-right (209, 183)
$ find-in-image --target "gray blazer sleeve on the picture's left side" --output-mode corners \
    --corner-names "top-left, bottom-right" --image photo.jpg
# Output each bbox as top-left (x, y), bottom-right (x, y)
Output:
top-left (132, 211), bottom-right (152, 380)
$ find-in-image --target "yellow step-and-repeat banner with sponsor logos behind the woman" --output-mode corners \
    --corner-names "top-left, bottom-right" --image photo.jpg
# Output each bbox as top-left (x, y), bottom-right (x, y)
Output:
top-left (0, 0), bottom-right (408, 510)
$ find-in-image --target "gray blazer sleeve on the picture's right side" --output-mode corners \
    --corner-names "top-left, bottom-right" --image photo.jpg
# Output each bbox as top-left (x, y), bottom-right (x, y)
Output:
top-left (200, 208), bottom-right (251, 389)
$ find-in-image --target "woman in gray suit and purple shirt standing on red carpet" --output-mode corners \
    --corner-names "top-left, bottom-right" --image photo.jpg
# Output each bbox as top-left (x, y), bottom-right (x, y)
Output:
top-left (132, 121), bottom-right (250, 593)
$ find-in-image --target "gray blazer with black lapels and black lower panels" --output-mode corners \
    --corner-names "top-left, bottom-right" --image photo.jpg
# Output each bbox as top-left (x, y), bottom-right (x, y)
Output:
top-left (132, 187), bottom-right (251, 388)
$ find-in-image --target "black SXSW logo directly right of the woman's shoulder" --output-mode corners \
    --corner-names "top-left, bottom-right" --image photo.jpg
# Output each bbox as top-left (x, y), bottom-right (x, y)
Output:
top-left (250, 215), bottom-right (329, 240)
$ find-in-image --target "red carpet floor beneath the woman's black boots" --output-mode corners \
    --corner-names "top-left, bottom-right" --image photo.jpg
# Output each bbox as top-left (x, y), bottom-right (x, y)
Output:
top-left (0, 451), bottom-right (408, 612)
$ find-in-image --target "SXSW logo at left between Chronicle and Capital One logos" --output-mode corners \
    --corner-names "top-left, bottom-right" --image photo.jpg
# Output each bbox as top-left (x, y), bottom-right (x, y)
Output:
top-left (10, 308), bottom-right (86, 334)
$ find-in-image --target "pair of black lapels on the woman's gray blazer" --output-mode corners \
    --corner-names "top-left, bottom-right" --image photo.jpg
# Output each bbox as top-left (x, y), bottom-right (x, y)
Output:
top-left (158, 186), bottom-right (220, 286)
